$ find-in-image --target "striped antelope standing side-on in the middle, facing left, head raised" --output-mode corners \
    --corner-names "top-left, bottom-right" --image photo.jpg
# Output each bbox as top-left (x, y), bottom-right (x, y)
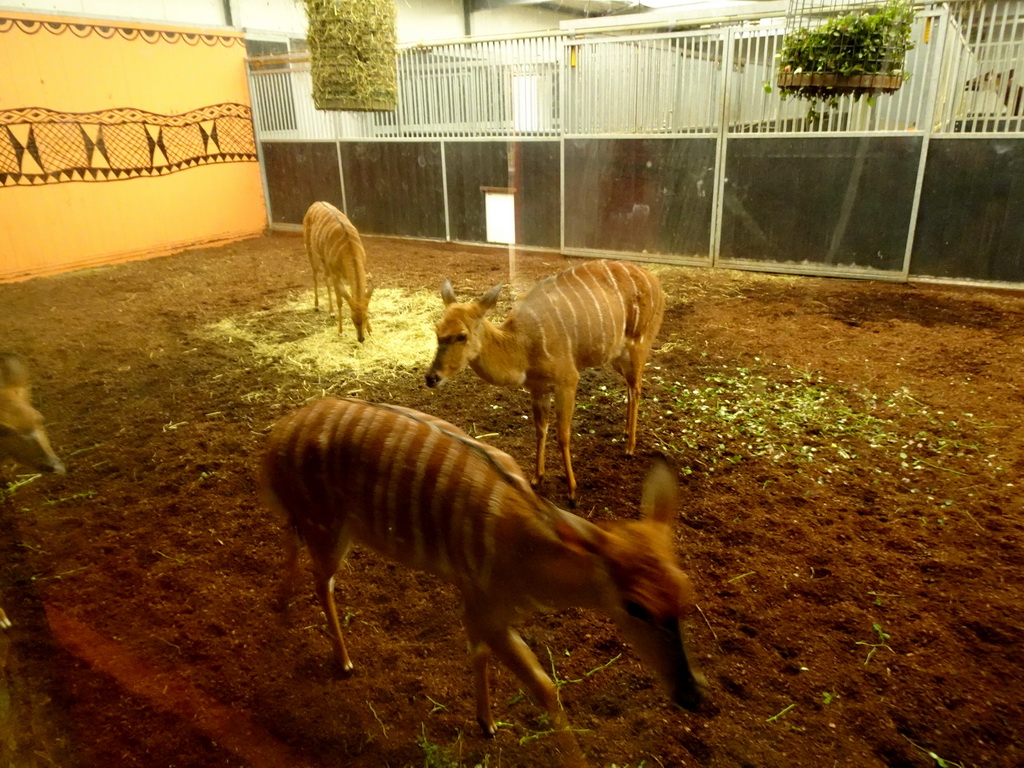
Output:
top-left (426, 261), bottom-right (665, 506)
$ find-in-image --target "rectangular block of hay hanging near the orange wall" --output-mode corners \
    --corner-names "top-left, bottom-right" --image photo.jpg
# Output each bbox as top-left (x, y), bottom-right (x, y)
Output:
top-left (303, 0), bottom-right (398, 112)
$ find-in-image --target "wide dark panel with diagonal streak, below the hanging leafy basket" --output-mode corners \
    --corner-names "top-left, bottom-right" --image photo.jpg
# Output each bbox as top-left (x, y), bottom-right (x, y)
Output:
top-left (721, 136), bottom-right (921, 271)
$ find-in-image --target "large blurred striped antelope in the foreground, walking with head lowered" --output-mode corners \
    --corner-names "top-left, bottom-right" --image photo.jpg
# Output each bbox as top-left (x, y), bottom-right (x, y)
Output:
top-left (260, 398), bottom-right (705, 761)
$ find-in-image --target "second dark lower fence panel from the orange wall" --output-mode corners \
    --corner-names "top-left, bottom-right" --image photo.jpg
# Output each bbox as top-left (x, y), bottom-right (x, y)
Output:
top-left (341, 141), bottom-right (444, 240)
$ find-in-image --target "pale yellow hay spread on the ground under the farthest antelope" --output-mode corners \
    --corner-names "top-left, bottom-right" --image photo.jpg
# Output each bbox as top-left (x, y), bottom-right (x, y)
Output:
top-left (207, 288), bottom-right (440, 387)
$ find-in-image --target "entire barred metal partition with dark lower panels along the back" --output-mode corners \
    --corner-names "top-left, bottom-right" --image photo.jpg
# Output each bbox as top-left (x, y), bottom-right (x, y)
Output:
top-left (250, 0), bottom-right (1024, 284)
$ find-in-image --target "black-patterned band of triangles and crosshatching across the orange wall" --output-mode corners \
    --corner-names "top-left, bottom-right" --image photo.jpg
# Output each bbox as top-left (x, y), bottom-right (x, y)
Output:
top-left (0, 103), bottom-right (257, 187)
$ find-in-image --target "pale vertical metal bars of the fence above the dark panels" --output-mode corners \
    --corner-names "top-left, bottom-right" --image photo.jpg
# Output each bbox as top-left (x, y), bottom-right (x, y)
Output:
top-left (250, 0), bottom-right (1024, 140)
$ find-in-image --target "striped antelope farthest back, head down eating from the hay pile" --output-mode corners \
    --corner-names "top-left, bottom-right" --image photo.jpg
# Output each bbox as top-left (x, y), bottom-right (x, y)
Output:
top-left (302, 202), bottom-right (374, 344)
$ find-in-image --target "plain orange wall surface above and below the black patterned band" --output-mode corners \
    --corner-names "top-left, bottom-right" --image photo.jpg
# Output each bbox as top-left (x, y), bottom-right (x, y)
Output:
top-left (0, 13), bottom-right (266, 281)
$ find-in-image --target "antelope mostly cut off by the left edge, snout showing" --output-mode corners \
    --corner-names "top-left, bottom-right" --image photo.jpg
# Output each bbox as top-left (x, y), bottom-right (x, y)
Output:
top-left (0, 352), bottom-right (65, 629)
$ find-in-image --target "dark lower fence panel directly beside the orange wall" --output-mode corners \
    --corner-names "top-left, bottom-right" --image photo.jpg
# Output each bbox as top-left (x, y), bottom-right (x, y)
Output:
top-left (263, 141), bottom-right (342, 224)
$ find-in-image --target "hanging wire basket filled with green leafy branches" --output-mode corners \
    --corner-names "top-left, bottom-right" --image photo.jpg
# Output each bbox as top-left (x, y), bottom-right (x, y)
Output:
top-left (775, 0), bottom-right (914, 116)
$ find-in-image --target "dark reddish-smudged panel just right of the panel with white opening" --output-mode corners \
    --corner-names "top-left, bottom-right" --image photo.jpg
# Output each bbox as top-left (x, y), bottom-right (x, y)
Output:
top-left (565, 138), bottom-right (716, 257)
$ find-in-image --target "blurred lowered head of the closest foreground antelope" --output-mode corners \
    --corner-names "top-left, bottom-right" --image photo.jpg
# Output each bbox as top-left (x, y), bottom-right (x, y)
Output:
top-left (558, 460), bottom-right (708, 711)
